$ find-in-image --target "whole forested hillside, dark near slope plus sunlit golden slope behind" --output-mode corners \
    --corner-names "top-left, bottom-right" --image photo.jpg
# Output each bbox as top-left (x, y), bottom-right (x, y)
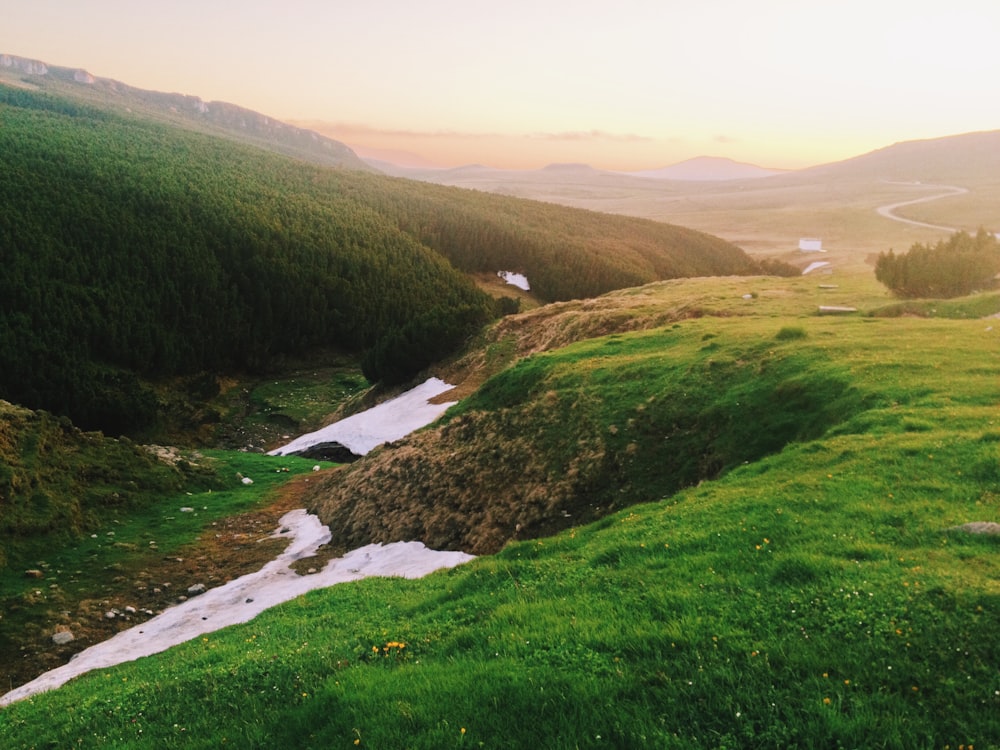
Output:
top-left (0, 86), bottom-right (757, 433)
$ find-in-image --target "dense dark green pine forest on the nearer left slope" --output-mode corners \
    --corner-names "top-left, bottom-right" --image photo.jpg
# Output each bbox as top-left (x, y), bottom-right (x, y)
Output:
top-left (0, 88), bottom-right (492, 433)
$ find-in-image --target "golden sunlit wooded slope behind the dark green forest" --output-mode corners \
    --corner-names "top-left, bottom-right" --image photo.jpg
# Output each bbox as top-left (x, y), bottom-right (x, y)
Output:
top-left (336, 175), bottom-right (772, 302)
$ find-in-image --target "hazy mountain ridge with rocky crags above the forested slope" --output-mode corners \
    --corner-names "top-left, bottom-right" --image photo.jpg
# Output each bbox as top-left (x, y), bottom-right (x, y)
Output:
top-left (0, 54), bottom-right (373, 172)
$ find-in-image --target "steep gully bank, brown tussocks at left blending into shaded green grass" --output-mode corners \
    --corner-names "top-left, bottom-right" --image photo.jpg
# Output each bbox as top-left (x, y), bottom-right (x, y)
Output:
top-left (310, 318), bottom-right (876, 554)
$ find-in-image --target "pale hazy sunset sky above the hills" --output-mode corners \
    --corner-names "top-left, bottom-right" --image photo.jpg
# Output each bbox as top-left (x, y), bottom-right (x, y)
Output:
top-left (0, 0), bottom-right (1000, 169)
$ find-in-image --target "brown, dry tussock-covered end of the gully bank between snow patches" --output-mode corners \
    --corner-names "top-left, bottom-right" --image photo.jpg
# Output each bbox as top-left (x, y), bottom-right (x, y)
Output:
top-left (305, 410), bottom-right (615, 554)
